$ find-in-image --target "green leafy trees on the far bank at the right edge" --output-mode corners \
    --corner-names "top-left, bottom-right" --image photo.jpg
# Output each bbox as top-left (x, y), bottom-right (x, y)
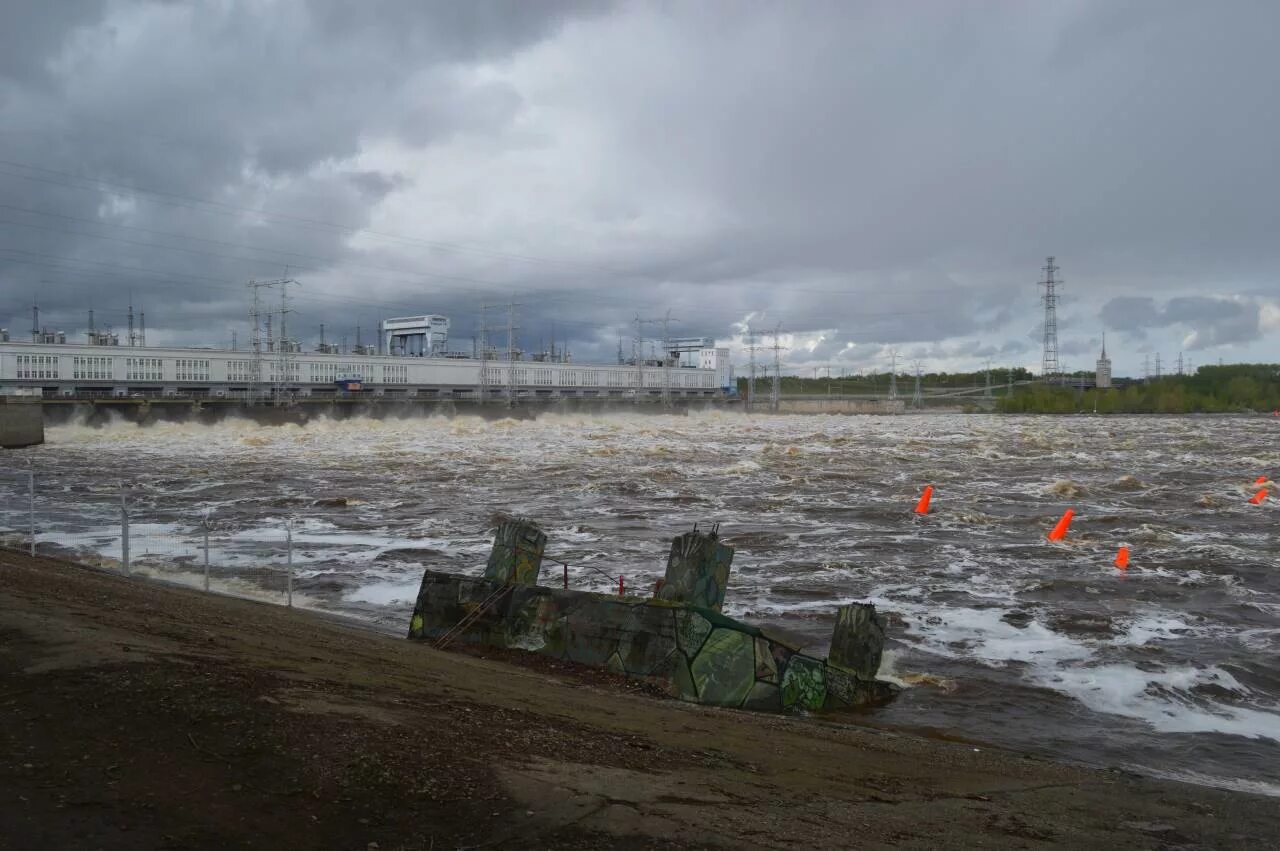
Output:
top-left (997, 363), bottom-right (1280, 413)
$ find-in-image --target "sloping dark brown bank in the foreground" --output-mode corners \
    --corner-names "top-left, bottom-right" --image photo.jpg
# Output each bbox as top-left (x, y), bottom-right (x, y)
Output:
top-left (0, 550), bottom-right (1280, 851)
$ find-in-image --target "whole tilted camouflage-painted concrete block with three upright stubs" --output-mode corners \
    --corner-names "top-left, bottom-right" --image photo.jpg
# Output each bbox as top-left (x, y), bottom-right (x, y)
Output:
top-left (408, 521), bottom-right (897, 712)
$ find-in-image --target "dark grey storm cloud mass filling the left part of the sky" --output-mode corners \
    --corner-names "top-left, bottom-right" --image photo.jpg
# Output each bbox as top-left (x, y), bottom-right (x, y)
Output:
top-left (0, 0), bottom-right (604, 339)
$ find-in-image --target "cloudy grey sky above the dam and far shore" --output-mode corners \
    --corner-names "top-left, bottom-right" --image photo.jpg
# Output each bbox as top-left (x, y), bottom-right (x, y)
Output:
top-left (0, 0), bottom-right (1280, 375)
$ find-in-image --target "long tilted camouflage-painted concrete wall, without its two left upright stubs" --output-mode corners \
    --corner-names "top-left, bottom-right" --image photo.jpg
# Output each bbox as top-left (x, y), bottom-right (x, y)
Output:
top-left (410, 571), bottom-right (896, 712)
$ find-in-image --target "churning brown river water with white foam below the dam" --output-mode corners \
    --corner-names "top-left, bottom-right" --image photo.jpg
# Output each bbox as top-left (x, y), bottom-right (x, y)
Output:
top-left (0, 413), bottom-right (1280, 795)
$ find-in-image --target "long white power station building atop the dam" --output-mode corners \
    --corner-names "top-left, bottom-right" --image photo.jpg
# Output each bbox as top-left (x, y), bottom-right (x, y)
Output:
top-left (0, 343), bottom-right (732, 399)
